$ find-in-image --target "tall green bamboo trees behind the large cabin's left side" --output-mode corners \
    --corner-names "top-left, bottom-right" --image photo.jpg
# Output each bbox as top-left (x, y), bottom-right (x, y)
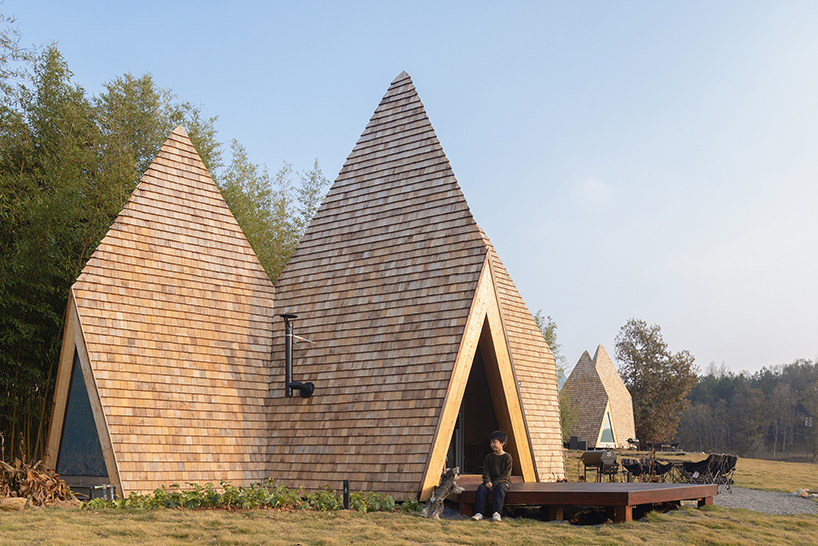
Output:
top-left (0, 14), bottom-right (329, 460)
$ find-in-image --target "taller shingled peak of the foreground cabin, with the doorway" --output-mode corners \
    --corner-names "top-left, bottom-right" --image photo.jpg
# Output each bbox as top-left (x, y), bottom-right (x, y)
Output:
top-left (269, 73), bottom-right (562, 495)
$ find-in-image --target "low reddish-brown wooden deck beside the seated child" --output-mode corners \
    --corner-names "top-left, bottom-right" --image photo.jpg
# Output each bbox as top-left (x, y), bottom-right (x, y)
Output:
top-left (457, 482), bottom-right (717, 523)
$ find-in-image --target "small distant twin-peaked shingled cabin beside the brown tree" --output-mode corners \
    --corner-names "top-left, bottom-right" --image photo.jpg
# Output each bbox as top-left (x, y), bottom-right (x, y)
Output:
top-left (562, 345), bottom-right (636, 449)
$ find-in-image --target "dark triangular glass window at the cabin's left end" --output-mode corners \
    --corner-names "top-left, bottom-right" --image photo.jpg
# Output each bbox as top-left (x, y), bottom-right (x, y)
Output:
top-left (57, 351), bottom-right (108, 476)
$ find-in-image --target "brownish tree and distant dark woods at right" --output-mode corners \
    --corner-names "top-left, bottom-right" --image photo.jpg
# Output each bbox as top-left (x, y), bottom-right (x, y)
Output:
top-left (615, 319), bottom-right (818, 461)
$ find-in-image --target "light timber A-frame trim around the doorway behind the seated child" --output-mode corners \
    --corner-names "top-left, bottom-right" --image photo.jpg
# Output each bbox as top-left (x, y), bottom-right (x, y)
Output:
top-left (419, 253), bottom-right (537, 501)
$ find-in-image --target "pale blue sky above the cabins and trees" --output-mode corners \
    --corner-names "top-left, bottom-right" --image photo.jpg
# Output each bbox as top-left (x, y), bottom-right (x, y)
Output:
top-left (9, 0), bottom-right (818, 371)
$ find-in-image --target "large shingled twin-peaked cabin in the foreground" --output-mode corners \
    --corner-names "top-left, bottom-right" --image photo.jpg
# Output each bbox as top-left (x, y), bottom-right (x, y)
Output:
top-left (47, 73), bottom-right (564, 498)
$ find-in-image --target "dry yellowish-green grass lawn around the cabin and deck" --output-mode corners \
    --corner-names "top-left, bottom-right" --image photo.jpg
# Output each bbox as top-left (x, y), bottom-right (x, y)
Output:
top-left (0, 453), bottom-right (818, 546)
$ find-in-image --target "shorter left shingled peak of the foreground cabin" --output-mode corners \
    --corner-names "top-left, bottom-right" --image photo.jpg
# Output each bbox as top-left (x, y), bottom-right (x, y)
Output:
top-left (47, 127), bottom-right (274, 495)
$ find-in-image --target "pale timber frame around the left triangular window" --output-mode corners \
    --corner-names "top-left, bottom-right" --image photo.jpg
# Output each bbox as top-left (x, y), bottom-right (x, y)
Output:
top-left (45, 287), bottom-right (124, 495)
